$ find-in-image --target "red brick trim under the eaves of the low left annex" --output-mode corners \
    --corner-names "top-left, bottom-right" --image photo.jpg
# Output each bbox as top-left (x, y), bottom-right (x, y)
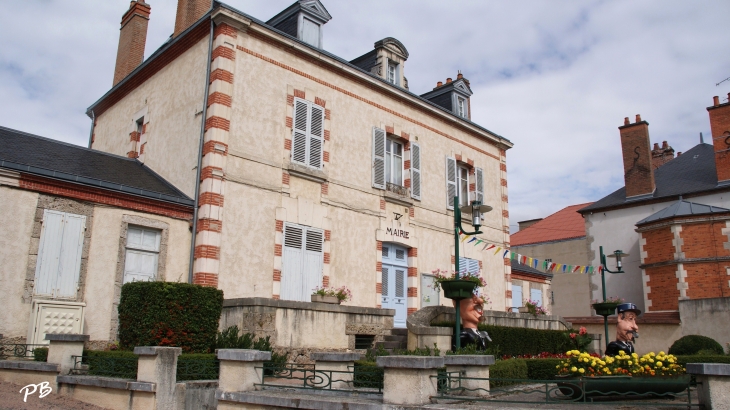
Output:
top-left (18, 173), bottom-right (193, 219)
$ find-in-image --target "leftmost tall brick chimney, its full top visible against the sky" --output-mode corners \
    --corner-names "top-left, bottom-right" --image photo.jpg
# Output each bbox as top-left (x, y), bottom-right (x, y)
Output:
top-left (113, 0), bottom-right (151, 85)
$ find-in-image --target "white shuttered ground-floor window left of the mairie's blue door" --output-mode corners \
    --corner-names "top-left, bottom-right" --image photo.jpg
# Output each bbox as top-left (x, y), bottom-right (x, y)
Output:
top-left (280, 224), bottom-right (324, 302)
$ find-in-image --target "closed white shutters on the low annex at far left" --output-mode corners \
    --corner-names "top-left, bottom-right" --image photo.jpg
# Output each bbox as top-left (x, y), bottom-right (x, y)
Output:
top-left (34, 209), bottom-right (86, 299)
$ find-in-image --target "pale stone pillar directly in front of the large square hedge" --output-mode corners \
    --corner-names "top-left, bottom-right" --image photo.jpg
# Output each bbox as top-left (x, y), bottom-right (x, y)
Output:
top-left (134, 346), bottom-right (182, 410)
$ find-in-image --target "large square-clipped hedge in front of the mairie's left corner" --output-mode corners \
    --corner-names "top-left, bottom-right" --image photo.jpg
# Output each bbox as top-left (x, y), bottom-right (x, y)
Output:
top-left (119, 282), bottom-right (223, 353)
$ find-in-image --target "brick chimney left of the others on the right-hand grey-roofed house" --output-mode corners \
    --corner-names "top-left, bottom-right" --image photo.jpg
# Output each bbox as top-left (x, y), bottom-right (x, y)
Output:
top-left (618, 114), bottom-right (655, 198)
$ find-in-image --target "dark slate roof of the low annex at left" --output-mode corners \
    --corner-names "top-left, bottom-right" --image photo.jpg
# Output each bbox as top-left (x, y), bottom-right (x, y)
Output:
top-left (0, 126), bottom-right (194, 205)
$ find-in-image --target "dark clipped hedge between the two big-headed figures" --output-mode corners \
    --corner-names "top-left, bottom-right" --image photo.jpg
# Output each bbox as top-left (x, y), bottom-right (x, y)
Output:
top-left (431, 322), bottom-right (573, 356)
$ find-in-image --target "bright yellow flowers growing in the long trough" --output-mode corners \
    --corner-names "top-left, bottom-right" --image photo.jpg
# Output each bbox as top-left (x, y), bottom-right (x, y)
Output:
top-left (556, 350), bottom-right (686, 376)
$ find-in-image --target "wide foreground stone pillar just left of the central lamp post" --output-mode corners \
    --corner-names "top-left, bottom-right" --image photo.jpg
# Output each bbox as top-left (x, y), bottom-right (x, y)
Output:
top-left (377, 356), bottom-right (444, 406)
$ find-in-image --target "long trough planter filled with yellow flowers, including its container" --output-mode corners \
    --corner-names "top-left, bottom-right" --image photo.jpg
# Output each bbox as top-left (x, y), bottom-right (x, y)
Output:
top-left (556, 350), bottom-right (689, 399)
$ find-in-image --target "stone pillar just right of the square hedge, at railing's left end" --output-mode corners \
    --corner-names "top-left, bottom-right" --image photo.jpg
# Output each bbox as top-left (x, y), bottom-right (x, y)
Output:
top-left (216, 349), bottom-right (271, 392)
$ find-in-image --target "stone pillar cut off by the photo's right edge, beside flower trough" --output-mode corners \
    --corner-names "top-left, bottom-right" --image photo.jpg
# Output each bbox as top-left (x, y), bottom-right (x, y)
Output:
top-left (687, 363), bottom-right (730, 410)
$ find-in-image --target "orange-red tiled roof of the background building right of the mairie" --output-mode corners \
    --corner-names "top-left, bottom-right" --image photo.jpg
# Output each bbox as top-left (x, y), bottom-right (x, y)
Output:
top-left (510, 202), bottom-right (590, 246)
